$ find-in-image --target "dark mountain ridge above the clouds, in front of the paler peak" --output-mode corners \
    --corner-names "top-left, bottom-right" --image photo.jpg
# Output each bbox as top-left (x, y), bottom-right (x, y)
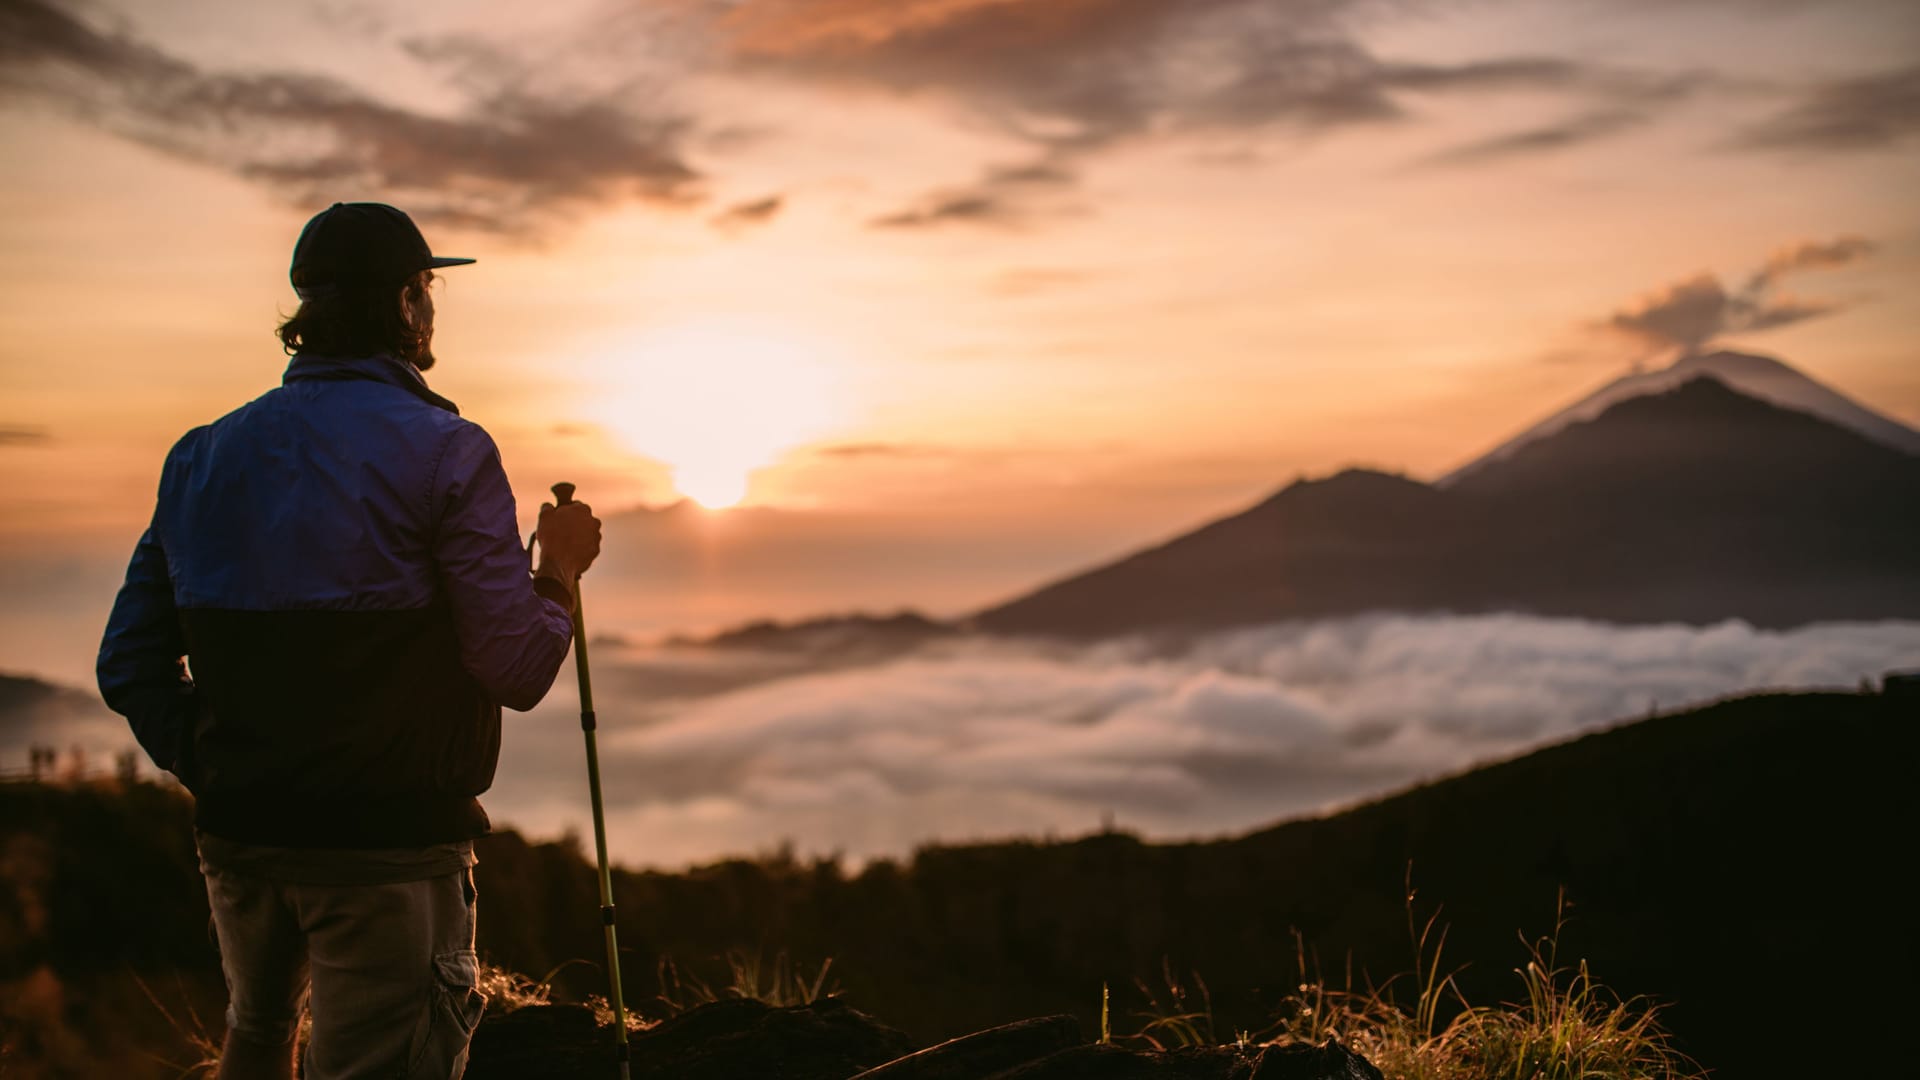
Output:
top-left (975, 379), bottom-right (1920, 636)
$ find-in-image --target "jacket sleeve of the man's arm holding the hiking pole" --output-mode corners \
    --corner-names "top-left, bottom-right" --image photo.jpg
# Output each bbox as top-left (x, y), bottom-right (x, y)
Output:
top-left (434, 423), bottom-right (574, 711)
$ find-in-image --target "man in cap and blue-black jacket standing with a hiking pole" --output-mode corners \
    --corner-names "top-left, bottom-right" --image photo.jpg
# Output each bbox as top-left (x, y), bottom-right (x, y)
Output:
top-left (98, 204), bottom-right (599, 1080)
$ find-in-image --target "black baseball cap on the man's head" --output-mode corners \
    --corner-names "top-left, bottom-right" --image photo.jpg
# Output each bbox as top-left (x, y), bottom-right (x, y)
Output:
top-left (286, 202), bottom-right (474, 300)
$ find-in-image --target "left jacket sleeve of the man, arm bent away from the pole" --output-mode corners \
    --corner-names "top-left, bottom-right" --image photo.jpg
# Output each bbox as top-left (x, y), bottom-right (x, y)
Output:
top-left (94, 527), bottom-right (194, 780)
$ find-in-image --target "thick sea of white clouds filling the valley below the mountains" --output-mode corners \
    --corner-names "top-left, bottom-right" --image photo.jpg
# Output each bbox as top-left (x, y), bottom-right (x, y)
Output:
top-left (486, 615), bottom-right (1920, 867)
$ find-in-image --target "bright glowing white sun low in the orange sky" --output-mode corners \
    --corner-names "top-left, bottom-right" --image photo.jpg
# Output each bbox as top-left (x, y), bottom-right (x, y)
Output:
top-left (591, 317), bottom-right (843, 509)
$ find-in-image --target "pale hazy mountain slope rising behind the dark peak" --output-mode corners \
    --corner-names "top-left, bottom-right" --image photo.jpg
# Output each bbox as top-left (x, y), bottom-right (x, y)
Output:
top-left (1434, 350), bottom-right (1920, 480)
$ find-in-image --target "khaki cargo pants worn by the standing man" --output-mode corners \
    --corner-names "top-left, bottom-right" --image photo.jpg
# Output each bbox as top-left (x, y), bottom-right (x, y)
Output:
top-left (205, 869), bottom-right (486, 1080)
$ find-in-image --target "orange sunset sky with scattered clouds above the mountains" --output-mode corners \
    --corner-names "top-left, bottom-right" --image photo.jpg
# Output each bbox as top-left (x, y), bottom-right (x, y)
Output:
top-left (0, 0), bottom-right (1920, 680)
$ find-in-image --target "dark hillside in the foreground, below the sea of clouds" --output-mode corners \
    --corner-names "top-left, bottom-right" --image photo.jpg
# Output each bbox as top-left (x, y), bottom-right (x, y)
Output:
top-left (0, 694), bottom-right (1920, 1076)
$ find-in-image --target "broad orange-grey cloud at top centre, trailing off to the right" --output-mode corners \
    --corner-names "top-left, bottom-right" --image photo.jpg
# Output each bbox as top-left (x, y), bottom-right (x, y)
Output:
top-left (716, 0), bottom-right (1703, 229)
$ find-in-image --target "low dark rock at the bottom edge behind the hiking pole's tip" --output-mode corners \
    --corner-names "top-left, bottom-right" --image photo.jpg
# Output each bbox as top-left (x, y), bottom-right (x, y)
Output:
top-left (467, 997), bottom-right (914, 1080)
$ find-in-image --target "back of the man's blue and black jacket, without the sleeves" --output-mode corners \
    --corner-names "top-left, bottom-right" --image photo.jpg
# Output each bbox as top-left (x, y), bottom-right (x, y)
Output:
top-left (154, 357), bottom-right (511, 847)
